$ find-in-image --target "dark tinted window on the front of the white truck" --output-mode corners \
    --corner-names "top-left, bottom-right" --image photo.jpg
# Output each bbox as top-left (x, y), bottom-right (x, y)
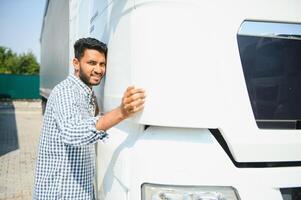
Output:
top-left (237, 21), bottom-right (301, 129)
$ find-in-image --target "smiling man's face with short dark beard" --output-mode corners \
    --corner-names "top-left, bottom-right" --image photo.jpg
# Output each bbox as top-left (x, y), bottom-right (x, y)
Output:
top-left (73, 49), bottom-right (106, 87)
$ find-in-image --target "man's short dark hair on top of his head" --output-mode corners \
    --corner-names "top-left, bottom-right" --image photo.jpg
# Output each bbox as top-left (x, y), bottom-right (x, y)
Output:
top-left (74, 37), bottom-right (107, 60)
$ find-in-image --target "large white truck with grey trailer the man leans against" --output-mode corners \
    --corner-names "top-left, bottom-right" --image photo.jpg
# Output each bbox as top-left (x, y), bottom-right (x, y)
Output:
top-left (41, 0), bottom-right (301, 200)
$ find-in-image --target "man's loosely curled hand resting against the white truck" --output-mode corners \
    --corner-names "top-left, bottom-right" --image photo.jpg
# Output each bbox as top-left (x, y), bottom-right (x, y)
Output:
top-left (120, 86), bottom-right (145, 119)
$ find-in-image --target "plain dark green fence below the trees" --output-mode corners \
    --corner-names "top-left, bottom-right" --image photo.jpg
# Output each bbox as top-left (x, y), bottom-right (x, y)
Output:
top-left (0, 74), bottom-right (40, 99)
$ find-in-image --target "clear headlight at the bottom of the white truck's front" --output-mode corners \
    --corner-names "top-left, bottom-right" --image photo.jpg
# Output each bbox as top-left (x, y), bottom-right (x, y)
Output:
top-left (142, 183), bottom-right (239, 200)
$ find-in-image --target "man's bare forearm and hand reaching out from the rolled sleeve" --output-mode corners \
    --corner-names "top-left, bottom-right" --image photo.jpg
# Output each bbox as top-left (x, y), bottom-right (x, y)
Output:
top-left (96, 86), bottom-right (145, 131)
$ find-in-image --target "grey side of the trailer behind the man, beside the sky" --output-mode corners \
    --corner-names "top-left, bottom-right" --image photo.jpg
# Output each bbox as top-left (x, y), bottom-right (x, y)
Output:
top-left (40, 0), bottom-right (69, 95)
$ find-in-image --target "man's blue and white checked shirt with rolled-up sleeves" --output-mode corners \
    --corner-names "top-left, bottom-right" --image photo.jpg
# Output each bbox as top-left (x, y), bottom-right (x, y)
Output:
top-left (33, 75), bottom-right (107, 200)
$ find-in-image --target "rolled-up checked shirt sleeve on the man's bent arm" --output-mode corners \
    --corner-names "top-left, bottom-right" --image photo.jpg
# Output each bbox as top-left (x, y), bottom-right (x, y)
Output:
top-left (53, 86), bottom-right (108, 146)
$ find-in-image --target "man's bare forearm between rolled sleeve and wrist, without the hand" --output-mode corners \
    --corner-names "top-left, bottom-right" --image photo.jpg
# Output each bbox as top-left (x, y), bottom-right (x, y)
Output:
top-left (96, 107), bottom-right (126, 131)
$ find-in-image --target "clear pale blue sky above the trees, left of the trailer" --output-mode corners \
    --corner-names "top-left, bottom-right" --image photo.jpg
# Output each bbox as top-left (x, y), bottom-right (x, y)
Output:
top-left (0, 0), bottom-right (46, 61)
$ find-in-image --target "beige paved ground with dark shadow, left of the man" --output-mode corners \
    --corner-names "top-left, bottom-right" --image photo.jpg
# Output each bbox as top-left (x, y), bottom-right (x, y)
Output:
top-left (0, 101), bottom-right (42, 200)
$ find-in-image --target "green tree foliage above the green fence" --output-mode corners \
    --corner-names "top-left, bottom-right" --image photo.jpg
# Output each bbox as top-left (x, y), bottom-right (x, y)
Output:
top-left (0, 46), bottom-right (40, 75)
